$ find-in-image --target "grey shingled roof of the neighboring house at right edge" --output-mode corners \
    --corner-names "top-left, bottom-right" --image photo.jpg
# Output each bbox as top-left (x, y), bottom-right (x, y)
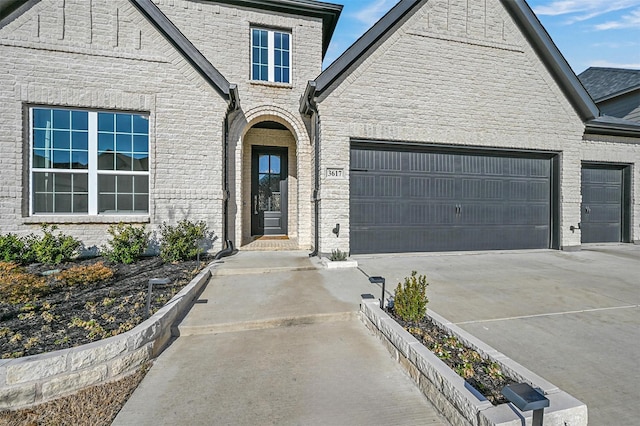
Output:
top-left (578, 67), bottom-right (640, 123)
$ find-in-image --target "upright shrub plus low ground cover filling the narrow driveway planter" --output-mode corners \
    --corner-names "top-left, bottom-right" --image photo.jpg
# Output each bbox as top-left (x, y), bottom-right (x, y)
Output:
top-left (389, 271), bottom-right (515, 405)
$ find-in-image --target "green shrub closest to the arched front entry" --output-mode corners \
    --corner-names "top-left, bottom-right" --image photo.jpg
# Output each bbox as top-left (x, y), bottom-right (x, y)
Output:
top-left (160, 219), bottom-right (207, 262)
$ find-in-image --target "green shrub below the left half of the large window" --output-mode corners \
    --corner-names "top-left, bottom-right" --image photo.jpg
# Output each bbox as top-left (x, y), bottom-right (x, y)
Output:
top-left (27, 224), bottom-right (82, 265)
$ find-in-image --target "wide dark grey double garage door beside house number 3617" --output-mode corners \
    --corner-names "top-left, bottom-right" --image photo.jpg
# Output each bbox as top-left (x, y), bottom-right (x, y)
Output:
top-left (350, 144), bottom-right (553, 254)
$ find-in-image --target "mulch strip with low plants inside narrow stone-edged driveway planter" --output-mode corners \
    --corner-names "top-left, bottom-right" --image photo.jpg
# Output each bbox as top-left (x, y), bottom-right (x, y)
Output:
top-left (387, 310), bottom-right (516, 405)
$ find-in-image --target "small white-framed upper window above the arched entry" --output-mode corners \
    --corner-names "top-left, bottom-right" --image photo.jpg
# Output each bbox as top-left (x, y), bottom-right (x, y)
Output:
top-left (251, 28), bottom-right (291, 83)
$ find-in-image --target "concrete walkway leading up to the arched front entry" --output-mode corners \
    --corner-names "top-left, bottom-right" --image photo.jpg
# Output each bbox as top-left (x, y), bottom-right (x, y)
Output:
top-left (113, 252), bottom-right (447, 425)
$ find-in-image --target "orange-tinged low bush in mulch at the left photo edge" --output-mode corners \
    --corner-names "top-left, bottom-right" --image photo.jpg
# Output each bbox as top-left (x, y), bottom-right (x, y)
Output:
top-left (0, 262), bottom-right (49, 304)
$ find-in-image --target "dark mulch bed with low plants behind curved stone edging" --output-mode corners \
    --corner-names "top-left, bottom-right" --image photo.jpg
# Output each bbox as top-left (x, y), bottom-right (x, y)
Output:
top-left (0, 257), bottom-right (204, 358)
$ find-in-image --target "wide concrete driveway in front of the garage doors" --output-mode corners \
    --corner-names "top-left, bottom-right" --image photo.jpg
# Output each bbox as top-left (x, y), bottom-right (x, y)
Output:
top-left (355, 245), bottom-right (640, 425)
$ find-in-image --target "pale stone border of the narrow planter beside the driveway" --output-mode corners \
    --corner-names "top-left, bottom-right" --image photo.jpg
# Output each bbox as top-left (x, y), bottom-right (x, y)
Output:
top-left (360, 299), bottom-right (588, 426)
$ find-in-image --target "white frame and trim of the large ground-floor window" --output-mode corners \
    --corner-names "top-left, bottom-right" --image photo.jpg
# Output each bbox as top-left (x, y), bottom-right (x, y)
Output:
top-left (28, 105), bottom-right (151, 216)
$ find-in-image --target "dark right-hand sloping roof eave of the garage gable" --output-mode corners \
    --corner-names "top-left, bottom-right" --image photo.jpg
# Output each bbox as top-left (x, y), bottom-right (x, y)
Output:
top-left (501, 0), bottom-right (600, 121)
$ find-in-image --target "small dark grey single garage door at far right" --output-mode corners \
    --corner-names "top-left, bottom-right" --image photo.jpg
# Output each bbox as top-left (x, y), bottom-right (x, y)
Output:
top-left (580, 164), bottom-right (630, 243)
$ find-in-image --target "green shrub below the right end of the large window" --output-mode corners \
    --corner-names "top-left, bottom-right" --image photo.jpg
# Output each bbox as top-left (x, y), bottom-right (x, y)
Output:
top-left (102, 223), bottom-right (151, 265)
